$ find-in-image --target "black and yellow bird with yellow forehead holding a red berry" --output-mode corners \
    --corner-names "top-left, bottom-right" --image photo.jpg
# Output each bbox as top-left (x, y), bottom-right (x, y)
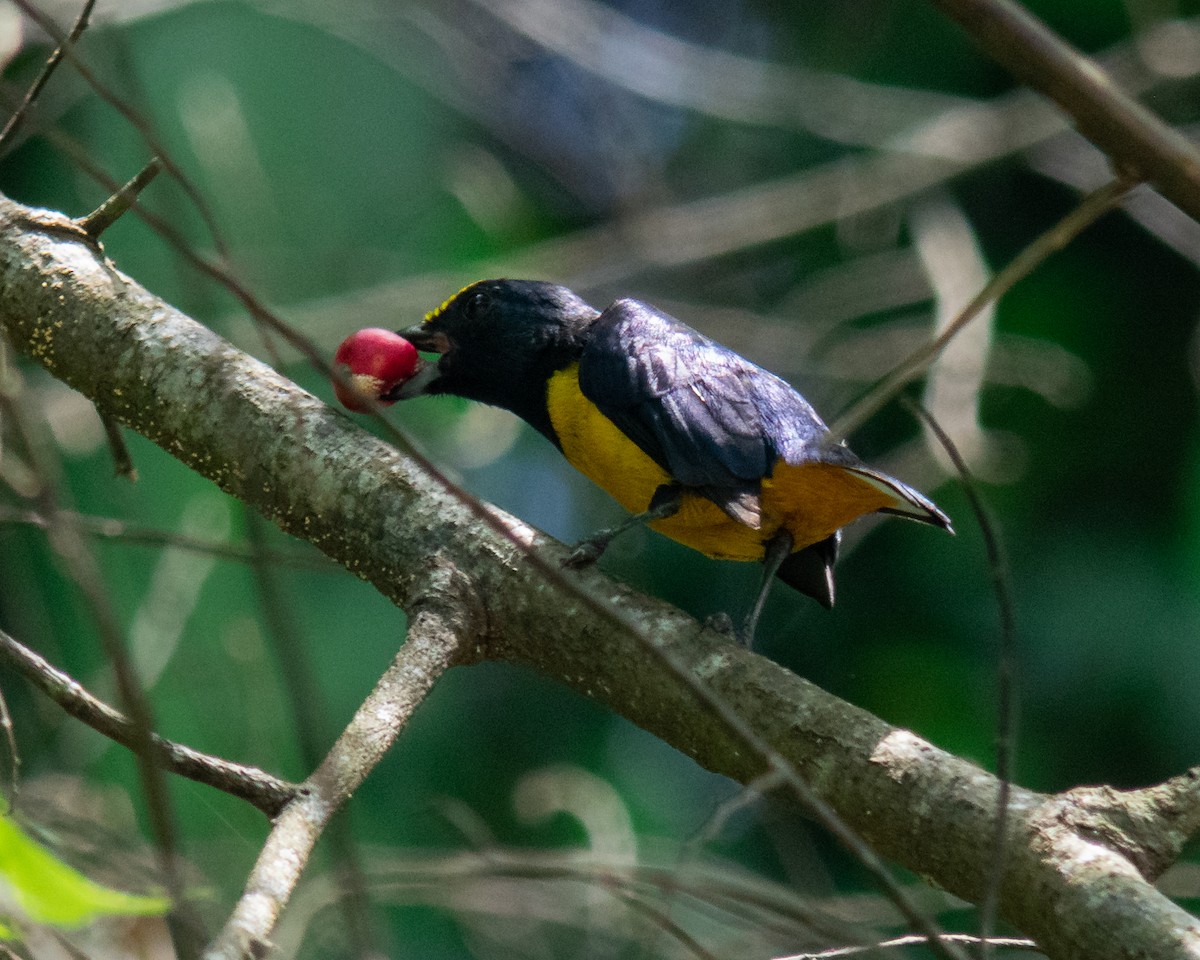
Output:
top-left (380, 278), bottom-right (953, 646)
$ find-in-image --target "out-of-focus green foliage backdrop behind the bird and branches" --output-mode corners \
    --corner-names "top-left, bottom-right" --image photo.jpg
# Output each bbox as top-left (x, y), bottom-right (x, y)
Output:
top-left (0, 0), bottom-right (1200, 956)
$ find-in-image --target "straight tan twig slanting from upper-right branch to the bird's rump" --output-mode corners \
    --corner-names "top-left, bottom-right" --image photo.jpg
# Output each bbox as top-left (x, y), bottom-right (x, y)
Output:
top-left (829, 179), bottom-right (1135, 442)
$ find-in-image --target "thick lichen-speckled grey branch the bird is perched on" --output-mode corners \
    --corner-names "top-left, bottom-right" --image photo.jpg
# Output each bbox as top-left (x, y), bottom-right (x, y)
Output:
top-left (0, 194), bottom-right (1200, 960)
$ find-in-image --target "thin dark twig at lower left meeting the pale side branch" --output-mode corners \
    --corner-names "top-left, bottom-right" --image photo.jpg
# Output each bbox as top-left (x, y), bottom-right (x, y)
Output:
top-left (0, 630), bottom-right (298, 817)
